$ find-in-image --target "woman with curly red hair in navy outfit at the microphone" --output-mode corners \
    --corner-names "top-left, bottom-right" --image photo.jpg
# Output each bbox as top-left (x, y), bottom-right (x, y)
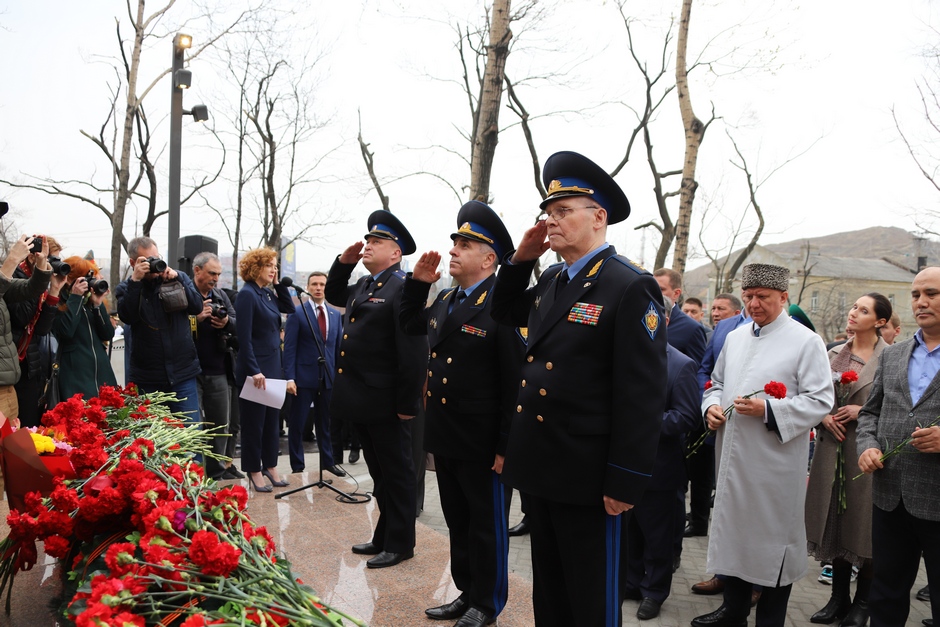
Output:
top-left (235, 248), bottom-right (294, 492)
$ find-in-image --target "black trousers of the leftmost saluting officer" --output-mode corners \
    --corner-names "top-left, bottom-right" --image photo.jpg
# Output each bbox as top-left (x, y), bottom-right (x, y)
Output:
top-left (355, 416), bottom-right (415, 553)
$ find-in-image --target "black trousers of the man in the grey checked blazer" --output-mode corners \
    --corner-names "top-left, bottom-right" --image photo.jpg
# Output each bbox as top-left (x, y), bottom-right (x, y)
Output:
top-left (869, 500), bottom-right (940, 627)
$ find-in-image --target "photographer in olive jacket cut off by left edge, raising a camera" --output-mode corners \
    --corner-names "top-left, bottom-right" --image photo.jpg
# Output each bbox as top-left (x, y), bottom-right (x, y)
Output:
top-left (0, 235), bottom-right (52, 426)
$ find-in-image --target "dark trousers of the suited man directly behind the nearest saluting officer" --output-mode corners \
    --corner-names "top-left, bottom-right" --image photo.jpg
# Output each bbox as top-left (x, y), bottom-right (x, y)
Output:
top-left (622, 490), bottom-right (676, 603)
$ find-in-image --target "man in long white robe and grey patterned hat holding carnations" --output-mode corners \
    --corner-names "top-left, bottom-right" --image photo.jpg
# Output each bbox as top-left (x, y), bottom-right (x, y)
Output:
top-left (692, 264), bottom-right (835, 627)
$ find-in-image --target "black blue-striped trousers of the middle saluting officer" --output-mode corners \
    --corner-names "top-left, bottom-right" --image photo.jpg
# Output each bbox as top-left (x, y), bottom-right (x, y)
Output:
top-left (434, 455), bottom-right (512, 617)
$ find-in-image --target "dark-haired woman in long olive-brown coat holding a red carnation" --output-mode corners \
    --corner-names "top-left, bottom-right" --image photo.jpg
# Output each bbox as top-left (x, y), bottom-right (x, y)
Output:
top-left (806, 292), bottom-right (892, 627)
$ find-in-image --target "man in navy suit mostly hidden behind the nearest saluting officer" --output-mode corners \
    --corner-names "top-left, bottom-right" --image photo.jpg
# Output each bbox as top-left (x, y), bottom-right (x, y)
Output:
top-left (624, 296), bottom-right (702, 620)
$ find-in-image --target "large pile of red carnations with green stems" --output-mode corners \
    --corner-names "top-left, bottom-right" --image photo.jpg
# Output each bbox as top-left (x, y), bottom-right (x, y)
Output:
top-left (0, 386), bottom-right (363, 627)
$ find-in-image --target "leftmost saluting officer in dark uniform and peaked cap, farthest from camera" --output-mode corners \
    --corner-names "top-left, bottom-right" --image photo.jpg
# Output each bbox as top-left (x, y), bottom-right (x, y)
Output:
top-left (326, 210), bottom-right (428, 568)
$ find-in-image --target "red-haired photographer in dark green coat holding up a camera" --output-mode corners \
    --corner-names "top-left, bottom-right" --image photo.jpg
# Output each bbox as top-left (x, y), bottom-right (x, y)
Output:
top-left (52, 257), bottom-right (117, 399)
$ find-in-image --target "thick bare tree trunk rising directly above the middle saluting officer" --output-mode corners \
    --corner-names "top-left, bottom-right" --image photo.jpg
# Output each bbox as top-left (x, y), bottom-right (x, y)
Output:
top-left (470, 0), bottom-right (512, 202)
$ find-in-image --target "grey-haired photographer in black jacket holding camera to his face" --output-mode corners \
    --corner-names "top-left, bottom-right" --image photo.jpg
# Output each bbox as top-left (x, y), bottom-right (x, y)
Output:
top-left (114, 237), bottom-right (203, 422)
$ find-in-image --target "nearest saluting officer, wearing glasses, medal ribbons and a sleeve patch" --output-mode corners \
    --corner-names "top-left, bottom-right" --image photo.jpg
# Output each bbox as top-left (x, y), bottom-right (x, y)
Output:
top-left (492, 152), bottom-right (666, 627)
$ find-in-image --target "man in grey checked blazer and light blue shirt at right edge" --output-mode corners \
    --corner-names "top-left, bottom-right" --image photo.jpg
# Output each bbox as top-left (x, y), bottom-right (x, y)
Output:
top-left (856, 267), bottom-right (940, 627)
